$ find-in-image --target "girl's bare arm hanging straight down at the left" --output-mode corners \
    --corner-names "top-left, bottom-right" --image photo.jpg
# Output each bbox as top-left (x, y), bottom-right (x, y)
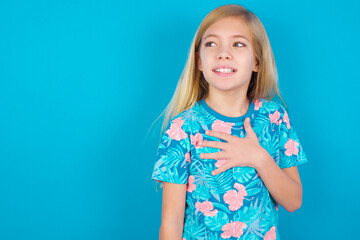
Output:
top-left (159, 182), bottom-right (186, 240)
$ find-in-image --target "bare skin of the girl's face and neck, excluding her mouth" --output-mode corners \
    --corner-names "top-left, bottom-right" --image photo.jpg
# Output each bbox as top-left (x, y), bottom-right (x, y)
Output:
top-left (197, 17), bottom-right (258, 117)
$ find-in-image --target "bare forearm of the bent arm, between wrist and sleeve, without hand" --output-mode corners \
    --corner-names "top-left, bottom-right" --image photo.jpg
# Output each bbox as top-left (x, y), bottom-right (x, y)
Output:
top-left (256, 158), bottom-right (302, 212)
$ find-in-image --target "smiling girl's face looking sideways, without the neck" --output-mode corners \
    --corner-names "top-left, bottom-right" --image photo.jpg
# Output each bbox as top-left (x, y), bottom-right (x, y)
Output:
top-left (197, 16), bottom-right (258, 94)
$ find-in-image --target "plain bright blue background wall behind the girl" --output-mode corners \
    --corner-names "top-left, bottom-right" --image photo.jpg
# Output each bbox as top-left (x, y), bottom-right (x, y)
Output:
top-left (0, 0), bottom-right (360, 240)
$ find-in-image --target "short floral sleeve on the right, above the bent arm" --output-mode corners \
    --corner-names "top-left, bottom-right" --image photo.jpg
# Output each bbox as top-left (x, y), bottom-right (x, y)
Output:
top-left (279, 104), bottom-right (307, 168)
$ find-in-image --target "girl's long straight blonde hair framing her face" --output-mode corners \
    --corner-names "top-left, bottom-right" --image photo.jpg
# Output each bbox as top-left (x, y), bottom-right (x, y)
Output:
top-left (148, 4), bottom-right (286, 139)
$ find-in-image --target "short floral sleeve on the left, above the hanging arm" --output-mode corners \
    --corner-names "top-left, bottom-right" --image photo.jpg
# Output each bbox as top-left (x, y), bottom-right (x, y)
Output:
top-left (151, 115), bottom-right (191, 184)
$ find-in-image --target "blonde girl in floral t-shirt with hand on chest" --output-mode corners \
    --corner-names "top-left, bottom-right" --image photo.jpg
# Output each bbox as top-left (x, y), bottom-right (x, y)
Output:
top-left (152, 4), bottom-right (307, 240)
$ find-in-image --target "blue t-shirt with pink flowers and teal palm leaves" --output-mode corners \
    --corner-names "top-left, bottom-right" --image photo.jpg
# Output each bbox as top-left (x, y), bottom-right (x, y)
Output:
top-left (151, 98), bottom-right (307, 240)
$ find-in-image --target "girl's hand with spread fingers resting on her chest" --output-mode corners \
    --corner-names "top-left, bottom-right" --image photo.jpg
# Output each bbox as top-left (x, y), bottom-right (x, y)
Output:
top-left (199, 118), bottom-right (271, 175)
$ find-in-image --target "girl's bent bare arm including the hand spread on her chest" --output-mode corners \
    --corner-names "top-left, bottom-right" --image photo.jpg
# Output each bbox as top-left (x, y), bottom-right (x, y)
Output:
top-left (198, 118), bottom-right (302, 212)
